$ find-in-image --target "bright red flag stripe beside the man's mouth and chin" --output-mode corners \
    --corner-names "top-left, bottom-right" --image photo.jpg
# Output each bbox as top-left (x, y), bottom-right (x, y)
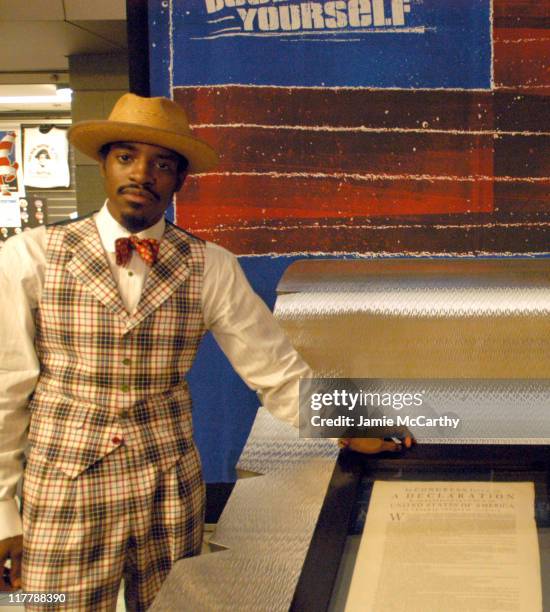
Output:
top-left (177, 175), bottom-right (493, 231)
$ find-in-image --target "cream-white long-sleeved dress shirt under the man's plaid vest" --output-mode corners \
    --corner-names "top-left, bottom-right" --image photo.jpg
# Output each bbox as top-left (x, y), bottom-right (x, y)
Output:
top-left (0, 205), bottom-right (311, 539)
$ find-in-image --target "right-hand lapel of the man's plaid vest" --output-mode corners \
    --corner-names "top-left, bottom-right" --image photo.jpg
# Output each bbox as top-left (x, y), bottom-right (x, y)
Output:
top-left (125, 223), bottom-right (191, 332)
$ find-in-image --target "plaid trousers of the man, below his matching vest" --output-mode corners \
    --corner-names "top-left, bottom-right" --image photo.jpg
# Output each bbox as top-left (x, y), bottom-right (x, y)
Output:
top-left (23, 446), bottom-right (204, 612)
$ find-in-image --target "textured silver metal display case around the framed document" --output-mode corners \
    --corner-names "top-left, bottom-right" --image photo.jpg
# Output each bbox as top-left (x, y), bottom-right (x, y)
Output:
top-left (151, 259), bottom-right (550, 612)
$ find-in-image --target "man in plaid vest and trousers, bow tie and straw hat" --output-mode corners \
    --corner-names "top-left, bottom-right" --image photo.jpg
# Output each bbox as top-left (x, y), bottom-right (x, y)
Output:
top-left (0, 94), bottom-right (406, 611)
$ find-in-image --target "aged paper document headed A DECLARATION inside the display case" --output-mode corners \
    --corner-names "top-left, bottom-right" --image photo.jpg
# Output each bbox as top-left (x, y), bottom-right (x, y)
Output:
top-left (345, 481), bottom-right (542, 612)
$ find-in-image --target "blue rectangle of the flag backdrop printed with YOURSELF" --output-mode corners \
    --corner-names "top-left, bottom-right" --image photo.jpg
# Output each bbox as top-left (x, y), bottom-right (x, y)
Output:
top-left (164, 0), bottom-right (491, 89)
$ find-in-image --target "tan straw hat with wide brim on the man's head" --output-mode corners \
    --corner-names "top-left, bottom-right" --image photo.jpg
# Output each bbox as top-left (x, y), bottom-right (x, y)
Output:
top-left (69, 94), bottom-right (218, 173)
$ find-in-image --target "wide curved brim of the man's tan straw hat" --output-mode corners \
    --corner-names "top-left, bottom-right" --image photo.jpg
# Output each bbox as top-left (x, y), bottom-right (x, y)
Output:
top-left (68, 120), bottom-right (218, 174)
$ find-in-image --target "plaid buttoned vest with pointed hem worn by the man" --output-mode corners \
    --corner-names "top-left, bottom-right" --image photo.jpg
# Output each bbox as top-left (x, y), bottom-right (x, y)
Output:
top-left (29, 218), bottom-right (205, 478)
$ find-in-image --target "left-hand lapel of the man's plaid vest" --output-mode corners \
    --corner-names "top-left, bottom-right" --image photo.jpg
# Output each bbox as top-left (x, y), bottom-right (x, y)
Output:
top-left (65, 218), bottom-right (129, 319)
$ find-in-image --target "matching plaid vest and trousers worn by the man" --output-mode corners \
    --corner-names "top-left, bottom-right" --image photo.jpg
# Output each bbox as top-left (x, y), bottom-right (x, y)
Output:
top-left (23, 219), bottom-right (209, 612)
